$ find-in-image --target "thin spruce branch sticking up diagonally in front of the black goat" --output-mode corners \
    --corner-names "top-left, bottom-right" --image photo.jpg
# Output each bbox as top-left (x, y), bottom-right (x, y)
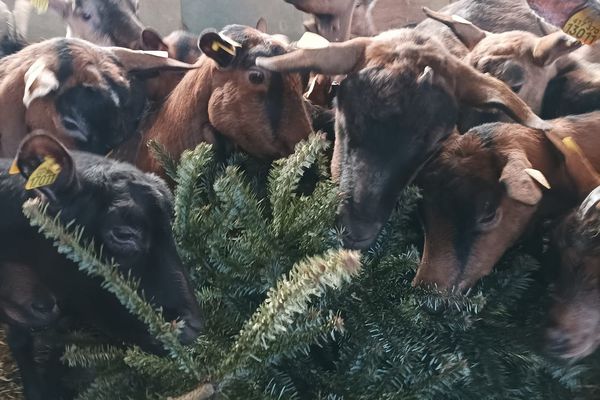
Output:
top-left (23, 199), bottom-right (195, 374)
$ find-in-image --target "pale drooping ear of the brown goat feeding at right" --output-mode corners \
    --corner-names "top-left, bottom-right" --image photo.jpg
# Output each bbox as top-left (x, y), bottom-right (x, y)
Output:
top-left (500, 153), bottom-right (550, 206)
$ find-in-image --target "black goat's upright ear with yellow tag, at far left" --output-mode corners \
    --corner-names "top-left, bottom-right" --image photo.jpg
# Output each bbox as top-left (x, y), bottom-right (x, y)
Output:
top-left (11, 131), bottom-right (78, 198)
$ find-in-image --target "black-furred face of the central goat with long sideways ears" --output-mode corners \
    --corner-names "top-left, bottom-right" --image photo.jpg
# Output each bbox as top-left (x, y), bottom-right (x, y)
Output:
top-left (336, 68), bottom-right (458, 248)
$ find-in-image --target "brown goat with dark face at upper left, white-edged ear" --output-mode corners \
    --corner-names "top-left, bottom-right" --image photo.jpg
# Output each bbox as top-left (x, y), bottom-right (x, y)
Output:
top-left (0, 39), bottom-right (193, 157)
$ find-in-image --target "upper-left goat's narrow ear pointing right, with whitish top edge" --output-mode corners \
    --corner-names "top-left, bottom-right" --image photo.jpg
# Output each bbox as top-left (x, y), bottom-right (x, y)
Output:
top-left (106, 47), bottom-right (198, 73)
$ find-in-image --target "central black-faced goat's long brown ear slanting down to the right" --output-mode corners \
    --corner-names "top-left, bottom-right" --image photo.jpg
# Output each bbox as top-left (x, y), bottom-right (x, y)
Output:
top-left (452, 61), bottom-right (551, 129)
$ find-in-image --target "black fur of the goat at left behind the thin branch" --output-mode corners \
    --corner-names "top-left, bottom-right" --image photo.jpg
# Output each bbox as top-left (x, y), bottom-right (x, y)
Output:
top-left (0, 145), bottom-right (199, 400)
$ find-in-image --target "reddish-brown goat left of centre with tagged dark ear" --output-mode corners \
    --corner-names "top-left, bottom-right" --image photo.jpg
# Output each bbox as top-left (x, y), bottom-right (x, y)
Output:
top-left (118, 25), bottom-right (312, 172)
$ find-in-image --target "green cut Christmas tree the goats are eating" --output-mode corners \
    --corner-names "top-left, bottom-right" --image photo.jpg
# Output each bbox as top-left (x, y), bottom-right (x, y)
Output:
top-left (24, 135), bottom-right (600, 400)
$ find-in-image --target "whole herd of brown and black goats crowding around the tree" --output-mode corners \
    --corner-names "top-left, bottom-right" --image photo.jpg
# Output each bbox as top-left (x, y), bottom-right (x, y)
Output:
top-left (0, 0), bottom-right (600, 400)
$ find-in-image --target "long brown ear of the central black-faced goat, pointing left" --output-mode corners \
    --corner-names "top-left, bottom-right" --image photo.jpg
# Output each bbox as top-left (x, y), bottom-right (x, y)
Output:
top-left (256, 38), bottom-right (371, 75)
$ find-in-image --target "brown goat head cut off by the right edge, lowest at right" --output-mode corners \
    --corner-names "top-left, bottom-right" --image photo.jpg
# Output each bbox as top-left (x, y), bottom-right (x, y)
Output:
top-left (546, 186), bottom-right (600, 360)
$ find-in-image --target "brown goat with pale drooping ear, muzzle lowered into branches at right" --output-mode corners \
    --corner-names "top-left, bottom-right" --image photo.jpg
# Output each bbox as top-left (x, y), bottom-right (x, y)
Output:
top-left (414, 113), bottom-right (600, 290)
